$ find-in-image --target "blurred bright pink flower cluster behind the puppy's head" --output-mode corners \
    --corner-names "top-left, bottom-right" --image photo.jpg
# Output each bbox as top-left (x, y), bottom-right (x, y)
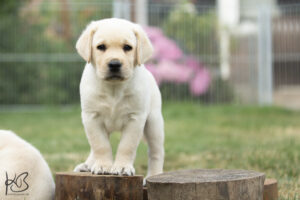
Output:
top-left (144, 27), bottom-right (211, 96)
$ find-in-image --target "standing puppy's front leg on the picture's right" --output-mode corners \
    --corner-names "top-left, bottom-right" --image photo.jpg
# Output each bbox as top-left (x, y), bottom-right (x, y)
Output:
top-left (111, 120), bottom-right (145, 176)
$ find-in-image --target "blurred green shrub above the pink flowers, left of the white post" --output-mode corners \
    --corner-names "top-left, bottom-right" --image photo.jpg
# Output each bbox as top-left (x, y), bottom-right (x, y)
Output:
top-left (162, 4), bottom-right (219, 61)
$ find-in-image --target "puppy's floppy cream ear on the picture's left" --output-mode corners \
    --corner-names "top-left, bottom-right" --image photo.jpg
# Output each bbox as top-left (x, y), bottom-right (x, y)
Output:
top-left (76, 22), bottom-right (96, 63)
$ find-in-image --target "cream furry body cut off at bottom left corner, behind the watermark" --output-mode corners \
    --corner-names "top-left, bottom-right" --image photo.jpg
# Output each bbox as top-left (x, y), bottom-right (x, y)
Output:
top-left (0, 130), bottom-right (55, 200)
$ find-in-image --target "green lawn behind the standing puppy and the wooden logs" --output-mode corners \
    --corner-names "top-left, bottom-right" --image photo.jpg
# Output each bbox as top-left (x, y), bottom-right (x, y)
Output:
top-left (0, 103), bottom-right (300, 200)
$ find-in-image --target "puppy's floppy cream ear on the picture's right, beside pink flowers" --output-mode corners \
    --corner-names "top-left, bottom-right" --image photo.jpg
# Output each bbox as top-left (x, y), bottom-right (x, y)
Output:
top-left (133, 24), bottom-right (153, 65)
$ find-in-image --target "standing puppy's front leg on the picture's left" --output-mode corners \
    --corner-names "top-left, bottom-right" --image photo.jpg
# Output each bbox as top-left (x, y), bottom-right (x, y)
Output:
top-left (75, 111), bottom-right (113, 174)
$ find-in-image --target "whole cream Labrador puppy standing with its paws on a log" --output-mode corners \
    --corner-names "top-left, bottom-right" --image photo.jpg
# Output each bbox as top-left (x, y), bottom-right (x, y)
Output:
top-left (74, 19), bottom-right (164, 177)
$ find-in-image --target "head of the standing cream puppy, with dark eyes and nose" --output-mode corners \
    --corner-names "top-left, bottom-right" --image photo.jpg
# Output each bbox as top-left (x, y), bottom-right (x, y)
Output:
top-left (76, 19), bottom-right (153, 81)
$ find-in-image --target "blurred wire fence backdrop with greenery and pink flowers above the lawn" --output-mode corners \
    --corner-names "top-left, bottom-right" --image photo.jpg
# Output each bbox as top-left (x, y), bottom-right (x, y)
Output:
top-left (0, 0), bottom-right (300, 108)
